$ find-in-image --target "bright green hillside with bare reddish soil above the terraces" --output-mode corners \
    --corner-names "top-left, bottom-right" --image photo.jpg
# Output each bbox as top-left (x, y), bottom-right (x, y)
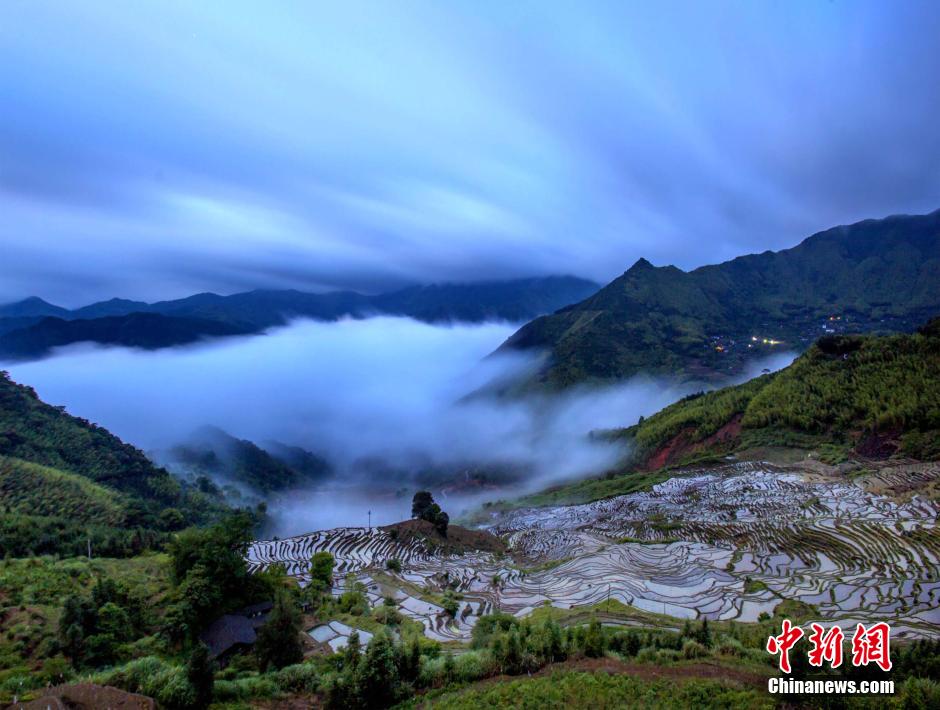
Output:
top-left (616, 318), bottom-right (940, 469)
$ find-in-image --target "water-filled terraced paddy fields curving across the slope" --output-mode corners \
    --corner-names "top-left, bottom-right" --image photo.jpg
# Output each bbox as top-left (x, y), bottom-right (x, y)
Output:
top-left (249, 463), bottom-right (940, 640)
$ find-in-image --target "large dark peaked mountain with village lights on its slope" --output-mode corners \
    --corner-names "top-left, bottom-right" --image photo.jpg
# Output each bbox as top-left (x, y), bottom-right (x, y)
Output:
top-left (503, 210), bottom-right (940, 387)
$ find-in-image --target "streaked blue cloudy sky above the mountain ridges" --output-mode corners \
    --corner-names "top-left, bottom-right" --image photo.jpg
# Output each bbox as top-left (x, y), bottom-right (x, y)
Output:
top-left (0, 0), bottom-right (940, 306)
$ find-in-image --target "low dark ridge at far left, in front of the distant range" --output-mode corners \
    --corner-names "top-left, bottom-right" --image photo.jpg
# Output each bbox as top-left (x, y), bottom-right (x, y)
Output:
top-left (0, 313), bottom-right (252, 360)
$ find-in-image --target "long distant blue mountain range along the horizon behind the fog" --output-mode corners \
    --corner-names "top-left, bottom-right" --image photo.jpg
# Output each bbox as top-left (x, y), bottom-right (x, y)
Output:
top-left (0, 276), bottom-right (598, 359)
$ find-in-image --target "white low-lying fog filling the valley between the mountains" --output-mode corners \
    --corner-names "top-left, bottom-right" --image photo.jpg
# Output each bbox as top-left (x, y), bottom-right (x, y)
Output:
top-left (8, 317), bottom-right (793, 535)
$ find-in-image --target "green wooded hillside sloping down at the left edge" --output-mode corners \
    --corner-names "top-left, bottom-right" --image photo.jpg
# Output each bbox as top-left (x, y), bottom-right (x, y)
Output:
top-left (0, 372), bottom-right (223, 556)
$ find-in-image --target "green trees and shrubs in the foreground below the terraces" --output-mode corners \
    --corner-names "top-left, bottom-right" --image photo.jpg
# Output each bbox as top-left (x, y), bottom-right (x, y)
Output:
top-left (0, 532), bottom-right (940, 708)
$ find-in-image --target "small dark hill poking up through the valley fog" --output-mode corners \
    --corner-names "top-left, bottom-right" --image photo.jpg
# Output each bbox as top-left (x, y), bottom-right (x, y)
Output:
top-left (159, 426), bottom-right (332, 494)
